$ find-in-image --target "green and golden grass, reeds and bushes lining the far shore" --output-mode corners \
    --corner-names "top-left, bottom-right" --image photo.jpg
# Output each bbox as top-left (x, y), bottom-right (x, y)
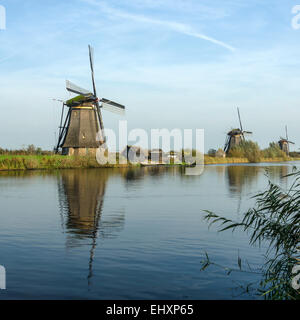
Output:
top-left (0, 141), bottom-right (300, 171)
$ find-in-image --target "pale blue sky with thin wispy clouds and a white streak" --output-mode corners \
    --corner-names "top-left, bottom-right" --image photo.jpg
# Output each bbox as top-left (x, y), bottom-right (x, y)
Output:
top-left (0, 0), bottom-right (300, 150)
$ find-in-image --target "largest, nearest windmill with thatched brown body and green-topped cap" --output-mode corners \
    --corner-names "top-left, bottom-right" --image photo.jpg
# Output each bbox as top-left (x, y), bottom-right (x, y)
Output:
top-left (55, 46), bottom-right (125, 155)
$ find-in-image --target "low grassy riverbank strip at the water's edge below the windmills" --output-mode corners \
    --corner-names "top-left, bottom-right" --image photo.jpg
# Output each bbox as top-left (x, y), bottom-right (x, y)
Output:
top-left (0, 155), bottom-right (300, 171)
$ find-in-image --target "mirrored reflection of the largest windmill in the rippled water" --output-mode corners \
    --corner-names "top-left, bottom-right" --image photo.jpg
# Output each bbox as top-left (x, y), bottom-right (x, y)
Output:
top-left (58, 169), bottom-right (125, 283)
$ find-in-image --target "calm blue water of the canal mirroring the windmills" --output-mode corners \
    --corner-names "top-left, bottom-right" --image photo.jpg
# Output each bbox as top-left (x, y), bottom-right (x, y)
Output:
top-left (0, 163), bottom-right (297, 299)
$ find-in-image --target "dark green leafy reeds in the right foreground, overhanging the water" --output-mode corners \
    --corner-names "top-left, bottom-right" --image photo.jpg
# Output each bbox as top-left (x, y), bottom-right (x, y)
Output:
top-left (202, 172), bottom-right (300, 300)
